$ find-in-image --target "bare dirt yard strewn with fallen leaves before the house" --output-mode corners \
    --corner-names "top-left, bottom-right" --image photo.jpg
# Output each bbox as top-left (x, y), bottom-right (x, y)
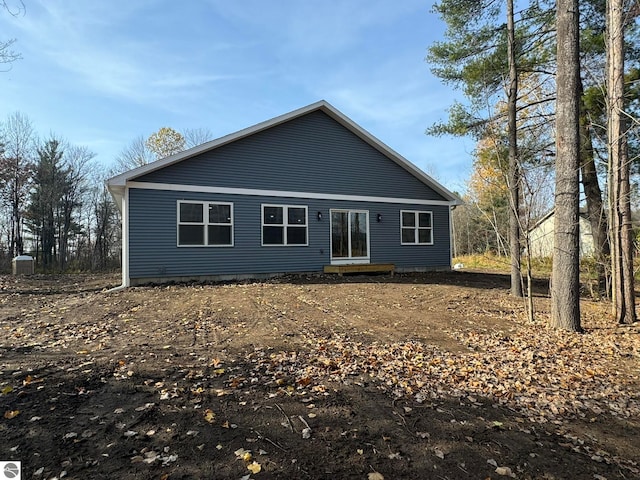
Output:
top-left (0, 272), bottom-right (640, 480)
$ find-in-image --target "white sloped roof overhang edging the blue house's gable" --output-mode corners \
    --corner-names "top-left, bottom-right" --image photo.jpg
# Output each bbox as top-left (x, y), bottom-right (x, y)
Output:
top-left (107, 100), bottom-right (462, 208)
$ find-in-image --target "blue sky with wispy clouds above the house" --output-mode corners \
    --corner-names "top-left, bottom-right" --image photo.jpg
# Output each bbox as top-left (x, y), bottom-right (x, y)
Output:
top-left (0, 0), bottom-right (473, 191)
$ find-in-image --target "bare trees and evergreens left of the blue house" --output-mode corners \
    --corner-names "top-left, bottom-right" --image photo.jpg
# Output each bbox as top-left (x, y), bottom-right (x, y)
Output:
top-left (0, 116), bottom-right (212, 272)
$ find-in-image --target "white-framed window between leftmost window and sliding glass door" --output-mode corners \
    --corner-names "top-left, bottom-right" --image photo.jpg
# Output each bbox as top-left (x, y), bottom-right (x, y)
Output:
top-left (262, 205), bottom-right (307, 245)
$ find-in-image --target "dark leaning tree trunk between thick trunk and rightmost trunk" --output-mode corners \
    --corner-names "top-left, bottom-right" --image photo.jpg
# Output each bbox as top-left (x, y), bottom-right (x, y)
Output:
top-left (580, 80), bottom-right (610, 295)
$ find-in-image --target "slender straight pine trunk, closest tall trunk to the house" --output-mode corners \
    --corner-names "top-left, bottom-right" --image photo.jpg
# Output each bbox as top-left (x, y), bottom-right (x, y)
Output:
top-left (507, 0), bottom-right (522, 297)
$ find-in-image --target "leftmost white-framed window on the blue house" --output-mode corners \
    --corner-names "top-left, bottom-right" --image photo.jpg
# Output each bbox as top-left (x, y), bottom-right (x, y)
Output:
top-left (178, 202), bottom-right (233, 247)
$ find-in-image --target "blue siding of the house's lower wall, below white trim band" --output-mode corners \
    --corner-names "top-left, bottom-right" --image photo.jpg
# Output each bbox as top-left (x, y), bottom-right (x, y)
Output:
top-left (129, 187), bottom-right (451, 279)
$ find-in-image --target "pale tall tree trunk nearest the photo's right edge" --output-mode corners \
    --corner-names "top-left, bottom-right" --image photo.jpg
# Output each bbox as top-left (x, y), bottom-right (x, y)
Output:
top-left (607, 0), bottom-right (636, 323)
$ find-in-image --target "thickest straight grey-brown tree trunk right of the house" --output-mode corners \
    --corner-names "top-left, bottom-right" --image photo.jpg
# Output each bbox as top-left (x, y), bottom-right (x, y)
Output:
top-left (551, 0), bottom-right (581, 332)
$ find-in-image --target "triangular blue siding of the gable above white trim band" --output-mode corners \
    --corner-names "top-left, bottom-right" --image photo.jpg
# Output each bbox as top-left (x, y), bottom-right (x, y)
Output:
top-left (135, 111), bottom-right (445, 202)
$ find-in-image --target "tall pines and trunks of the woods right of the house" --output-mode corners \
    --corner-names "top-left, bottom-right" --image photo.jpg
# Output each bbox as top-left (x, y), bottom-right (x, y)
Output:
top-left (427, 0), bottom-right (640, 330)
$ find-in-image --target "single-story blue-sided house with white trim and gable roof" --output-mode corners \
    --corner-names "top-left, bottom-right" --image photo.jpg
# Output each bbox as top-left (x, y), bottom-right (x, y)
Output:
top-left (107, 101), bottom-right (460, 286)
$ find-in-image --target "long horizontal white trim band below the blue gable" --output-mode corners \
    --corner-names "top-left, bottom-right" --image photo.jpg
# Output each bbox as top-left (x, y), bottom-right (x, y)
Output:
top-left (127, 182), bottom-right (454, 206)
